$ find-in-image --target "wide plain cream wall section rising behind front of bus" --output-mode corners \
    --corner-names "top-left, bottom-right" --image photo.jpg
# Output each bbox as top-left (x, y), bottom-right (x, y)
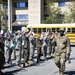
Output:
top-left (28, 0), bottom-right (41, 24)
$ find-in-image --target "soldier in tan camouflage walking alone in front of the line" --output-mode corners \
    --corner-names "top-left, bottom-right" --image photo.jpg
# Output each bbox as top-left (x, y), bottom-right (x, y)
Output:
top-left (52, 28), bottom-right (71, 75)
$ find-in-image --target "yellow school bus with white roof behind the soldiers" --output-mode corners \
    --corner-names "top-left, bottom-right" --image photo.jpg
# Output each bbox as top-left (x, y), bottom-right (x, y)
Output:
top-left (27, 24), bottom-right (75, 43)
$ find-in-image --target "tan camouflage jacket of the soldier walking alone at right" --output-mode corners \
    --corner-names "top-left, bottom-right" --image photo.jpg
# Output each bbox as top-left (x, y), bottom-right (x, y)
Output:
top-left (52, 35), bottom-right (71, 54)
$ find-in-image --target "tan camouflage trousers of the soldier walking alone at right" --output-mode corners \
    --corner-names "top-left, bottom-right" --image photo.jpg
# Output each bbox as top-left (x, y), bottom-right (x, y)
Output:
top-left (54, 53), bottom-right (66, 72)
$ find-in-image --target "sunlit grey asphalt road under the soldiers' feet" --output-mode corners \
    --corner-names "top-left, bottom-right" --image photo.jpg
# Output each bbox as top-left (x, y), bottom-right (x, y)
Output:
top-left (3, 46), bottom-right (75, 75)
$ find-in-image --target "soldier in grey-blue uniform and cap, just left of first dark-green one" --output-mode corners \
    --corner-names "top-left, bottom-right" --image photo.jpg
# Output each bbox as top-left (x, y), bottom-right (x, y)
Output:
top-left (15, 30), bottom-right (22, 68)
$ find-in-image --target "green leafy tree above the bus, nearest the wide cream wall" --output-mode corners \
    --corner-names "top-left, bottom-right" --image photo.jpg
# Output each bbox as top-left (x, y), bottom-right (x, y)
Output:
top-left (43, 0), bottom-right (64, 24)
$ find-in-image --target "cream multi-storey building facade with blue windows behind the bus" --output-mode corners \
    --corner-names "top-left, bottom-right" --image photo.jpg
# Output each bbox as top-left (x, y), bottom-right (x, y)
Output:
top-left (3, 0), bottom-right (75, 31)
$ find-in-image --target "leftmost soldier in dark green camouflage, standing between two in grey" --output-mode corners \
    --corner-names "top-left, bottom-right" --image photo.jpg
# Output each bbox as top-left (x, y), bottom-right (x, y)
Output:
top-left (23, 32), bottom-right (30, 67)
